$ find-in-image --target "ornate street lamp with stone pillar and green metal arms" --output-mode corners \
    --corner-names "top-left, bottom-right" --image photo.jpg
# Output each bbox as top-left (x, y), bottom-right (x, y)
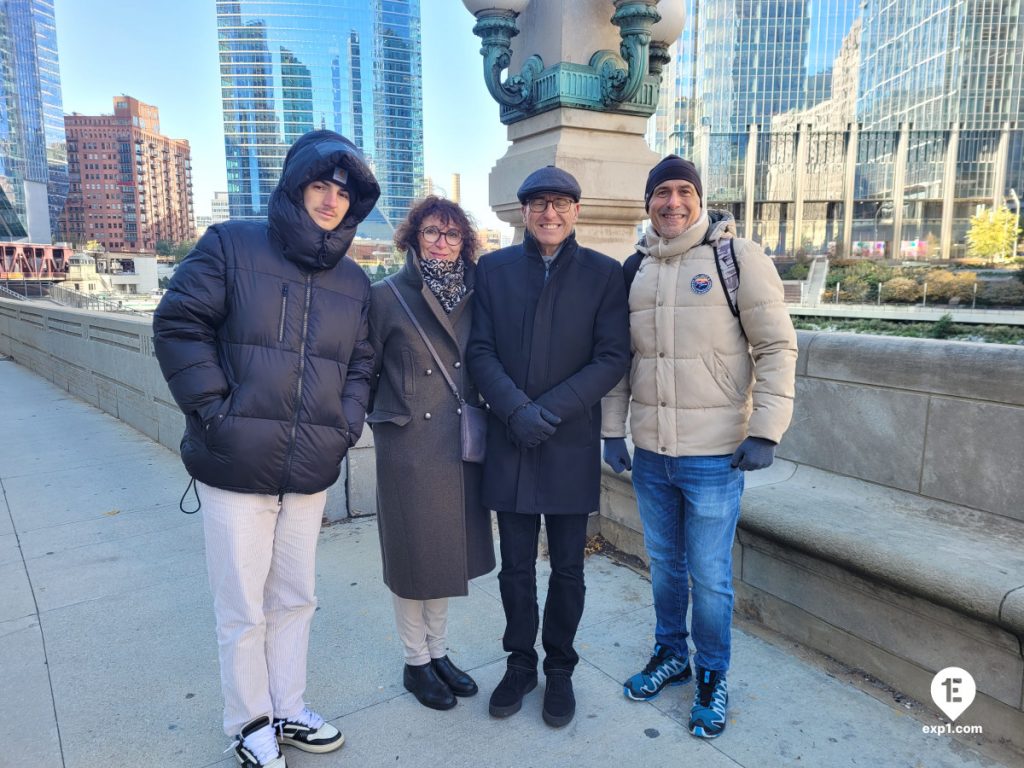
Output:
top-left (463, 0), bottom-right (685, 258)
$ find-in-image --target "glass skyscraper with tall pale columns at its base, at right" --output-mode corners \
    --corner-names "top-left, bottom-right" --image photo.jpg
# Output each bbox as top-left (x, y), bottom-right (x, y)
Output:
top-left (652, 0), bottom-right (1024, 258)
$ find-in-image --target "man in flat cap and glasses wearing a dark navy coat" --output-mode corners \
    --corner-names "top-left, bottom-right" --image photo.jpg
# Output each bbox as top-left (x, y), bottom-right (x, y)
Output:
top-left (468, 166), bottom-right (630, 728)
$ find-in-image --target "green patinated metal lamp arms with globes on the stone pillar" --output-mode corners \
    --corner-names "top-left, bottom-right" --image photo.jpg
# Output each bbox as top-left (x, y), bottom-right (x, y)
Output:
top-left (463, 0), bottom-right (685, 125)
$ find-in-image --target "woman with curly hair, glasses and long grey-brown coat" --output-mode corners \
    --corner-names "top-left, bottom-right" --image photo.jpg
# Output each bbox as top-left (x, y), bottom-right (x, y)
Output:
top-left (367, 197), bottom-right (495, 710)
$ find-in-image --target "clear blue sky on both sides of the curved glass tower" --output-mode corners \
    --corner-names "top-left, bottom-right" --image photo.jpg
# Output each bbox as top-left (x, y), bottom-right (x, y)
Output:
top-left (53, 0), bottom-right (508, 226)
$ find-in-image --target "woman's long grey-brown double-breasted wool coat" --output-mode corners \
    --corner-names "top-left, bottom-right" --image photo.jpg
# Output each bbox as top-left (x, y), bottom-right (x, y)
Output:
top-left (367, 252), bottom-right (495, 600)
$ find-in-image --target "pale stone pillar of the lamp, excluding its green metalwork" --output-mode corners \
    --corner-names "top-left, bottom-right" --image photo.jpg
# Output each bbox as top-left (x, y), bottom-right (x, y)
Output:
top-left (489, 0), bottom-right (659, 259)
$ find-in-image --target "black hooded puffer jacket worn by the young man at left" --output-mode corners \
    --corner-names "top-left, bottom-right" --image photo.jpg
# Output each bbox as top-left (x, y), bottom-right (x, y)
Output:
top-left (153, 131), bottom-right (380, 495)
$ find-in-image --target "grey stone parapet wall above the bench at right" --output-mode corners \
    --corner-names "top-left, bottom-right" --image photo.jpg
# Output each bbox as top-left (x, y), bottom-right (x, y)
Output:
top-left (778, 332), bottom-right (1024, 521)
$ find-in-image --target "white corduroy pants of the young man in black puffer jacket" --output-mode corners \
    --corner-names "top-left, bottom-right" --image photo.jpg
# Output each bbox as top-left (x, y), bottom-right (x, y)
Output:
top-left (196, 482), bottom-right (327, 736)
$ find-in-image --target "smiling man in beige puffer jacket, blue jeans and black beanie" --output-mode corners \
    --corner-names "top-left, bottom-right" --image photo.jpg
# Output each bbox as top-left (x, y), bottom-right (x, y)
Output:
top-left (601, 155), bottom-right (797, 738)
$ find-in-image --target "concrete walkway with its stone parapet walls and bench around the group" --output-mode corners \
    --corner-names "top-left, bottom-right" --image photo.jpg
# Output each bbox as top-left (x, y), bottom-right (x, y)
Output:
top-left (0, 298), bottom-right (1024, 768)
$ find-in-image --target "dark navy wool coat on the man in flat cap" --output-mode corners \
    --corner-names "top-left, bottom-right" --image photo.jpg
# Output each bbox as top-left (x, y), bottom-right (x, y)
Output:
top-left (467, 233), bottom-right (630, 514)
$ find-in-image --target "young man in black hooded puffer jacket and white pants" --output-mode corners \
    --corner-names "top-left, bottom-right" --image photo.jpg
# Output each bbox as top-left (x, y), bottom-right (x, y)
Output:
top-left (153, 130), bottom-right (380, 768)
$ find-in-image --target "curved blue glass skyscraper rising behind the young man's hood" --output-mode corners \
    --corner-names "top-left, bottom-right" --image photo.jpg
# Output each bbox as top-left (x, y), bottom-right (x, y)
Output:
top-left (217, 0), bottom-right (423, 231)
